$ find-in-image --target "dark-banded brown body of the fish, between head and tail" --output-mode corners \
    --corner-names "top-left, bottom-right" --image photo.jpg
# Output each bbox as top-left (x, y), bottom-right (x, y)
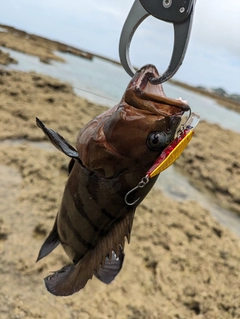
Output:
top-left (57, 159), bottom-right (154, 263)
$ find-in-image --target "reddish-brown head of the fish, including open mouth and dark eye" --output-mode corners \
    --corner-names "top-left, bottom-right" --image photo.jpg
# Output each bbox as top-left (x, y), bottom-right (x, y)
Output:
top-left (77, 65), bottom-right (190, 178)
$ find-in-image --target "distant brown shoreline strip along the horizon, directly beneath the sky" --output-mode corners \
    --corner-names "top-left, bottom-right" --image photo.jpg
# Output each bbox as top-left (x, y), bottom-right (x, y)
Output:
top-left (0, 24), bottom-right (240, 113)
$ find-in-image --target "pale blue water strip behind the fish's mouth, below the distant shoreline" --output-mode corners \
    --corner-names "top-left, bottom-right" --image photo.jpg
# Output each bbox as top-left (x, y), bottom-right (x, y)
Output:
top-left (0, 47), bottom-right (240, 132)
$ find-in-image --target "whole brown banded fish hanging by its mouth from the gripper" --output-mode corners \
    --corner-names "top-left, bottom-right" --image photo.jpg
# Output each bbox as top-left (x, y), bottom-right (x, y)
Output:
top-left (36, 64), bottom-right (190, 296)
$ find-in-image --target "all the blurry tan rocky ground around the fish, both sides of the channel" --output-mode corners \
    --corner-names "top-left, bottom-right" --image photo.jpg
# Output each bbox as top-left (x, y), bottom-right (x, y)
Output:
top-left (0, 25), bottom-right (240, 319)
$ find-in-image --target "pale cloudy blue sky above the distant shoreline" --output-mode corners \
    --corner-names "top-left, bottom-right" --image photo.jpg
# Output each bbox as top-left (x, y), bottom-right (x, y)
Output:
top-left (0, 0), bottom-right (240, 94)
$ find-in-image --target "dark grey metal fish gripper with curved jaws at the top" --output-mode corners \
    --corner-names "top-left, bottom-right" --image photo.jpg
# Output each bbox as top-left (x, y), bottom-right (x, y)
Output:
top-left (119, 0), bottom-right (196, 84)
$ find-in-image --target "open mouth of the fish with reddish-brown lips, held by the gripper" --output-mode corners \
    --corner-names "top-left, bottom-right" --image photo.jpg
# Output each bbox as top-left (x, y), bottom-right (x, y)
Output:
top-left (124, 64), bottom-right (190, 116)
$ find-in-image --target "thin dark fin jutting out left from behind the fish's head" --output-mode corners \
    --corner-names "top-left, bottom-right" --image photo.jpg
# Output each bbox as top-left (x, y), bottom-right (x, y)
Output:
top-left (36, 117), bottom-right (79, 159)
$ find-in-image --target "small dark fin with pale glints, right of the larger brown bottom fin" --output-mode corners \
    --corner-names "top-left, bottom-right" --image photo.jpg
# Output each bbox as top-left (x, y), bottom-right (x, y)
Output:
top-left (94, 251), bottom-right (124, 284)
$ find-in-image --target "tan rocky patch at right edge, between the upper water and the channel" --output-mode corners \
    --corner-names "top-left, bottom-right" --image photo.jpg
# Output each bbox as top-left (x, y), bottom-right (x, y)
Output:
top-left (176, 121), bottom-right (240, 216)
